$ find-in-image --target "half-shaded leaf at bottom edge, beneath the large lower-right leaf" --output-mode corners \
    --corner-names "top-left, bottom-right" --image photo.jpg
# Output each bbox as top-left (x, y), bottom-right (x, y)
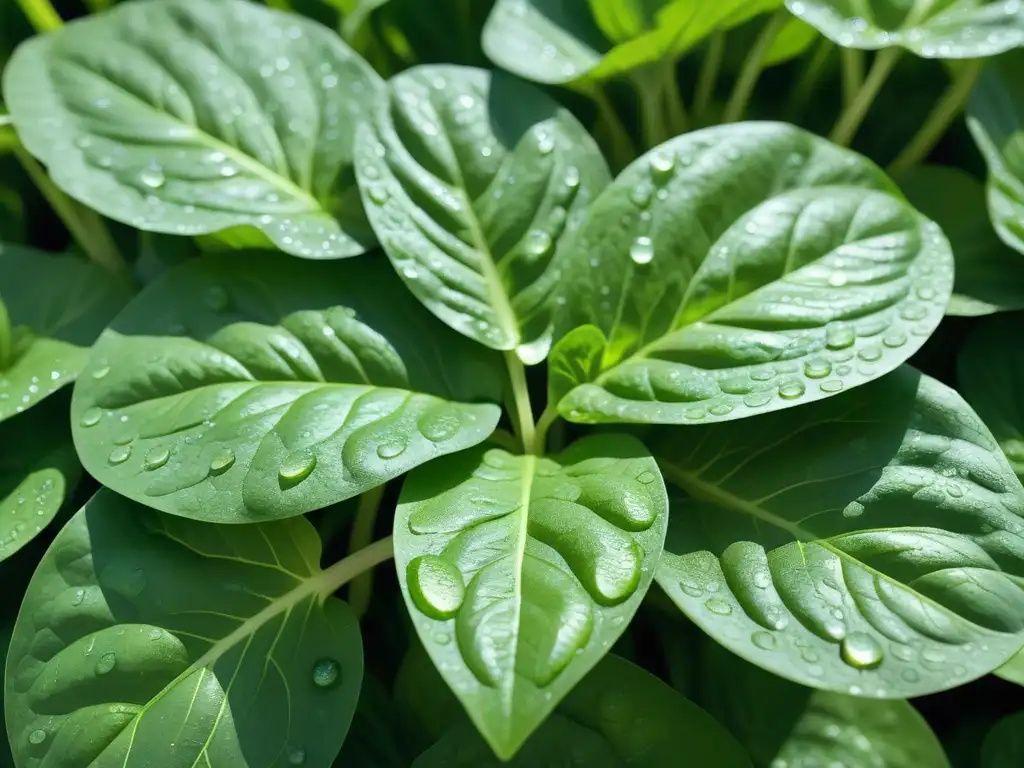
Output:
top-left (699, 642), bottom-right (949, 768)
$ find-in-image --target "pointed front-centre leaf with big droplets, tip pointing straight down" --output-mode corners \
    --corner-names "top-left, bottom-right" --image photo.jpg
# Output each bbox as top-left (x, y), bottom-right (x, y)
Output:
top-left (394, 434), bottom-right (667, 759)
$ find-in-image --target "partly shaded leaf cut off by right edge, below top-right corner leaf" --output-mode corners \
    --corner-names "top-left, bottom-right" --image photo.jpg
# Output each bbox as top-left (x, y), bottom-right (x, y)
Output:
top-left (967, 51), bottom-right (1024, 259)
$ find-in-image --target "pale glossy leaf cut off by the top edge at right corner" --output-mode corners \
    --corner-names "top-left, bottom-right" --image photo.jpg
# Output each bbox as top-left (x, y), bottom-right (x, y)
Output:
top-left (785, 0), bottom-right (1024, 58)
